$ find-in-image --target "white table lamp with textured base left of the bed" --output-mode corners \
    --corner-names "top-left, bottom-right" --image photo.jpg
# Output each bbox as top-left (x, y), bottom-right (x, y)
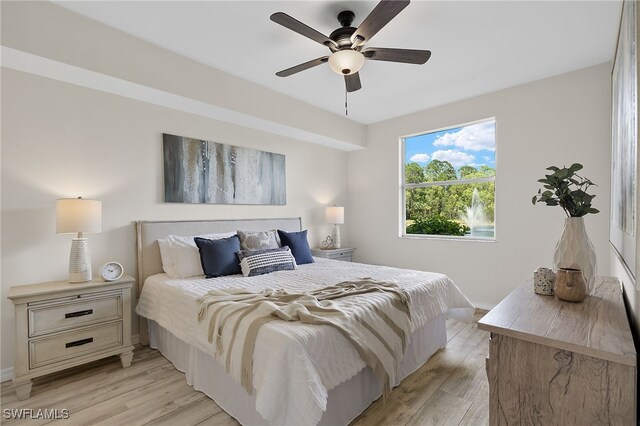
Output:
top-left (56, 197), bottom-right (102, 283)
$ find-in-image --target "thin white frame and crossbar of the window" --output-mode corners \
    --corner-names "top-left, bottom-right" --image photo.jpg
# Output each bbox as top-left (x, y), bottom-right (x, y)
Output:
top-left (399, 117), bottom-right (498, 243)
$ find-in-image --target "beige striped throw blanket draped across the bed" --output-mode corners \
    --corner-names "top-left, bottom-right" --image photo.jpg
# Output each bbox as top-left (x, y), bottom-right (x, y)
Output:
top-left (197, 278), bottom-right (411, 394)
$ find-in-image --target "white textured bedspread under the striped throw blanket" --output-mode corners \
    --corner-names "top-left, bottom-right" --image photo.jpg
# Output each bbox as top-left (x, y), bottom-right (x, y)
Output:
top-left (136, 258), bottom-right (473, 425)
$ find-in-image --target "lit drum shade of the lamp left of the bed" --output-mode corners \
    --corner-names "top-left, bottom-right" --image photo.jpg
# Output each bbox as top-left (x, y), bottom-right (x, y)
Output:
top-left (56, 198), bottom-right (102, 234)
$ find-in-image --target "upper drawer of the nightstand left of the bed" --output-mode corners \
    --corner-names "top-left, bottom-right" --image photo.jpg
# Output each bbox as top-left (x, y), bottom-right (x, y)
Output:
top-left (29, 291), bottom-right (122, 337)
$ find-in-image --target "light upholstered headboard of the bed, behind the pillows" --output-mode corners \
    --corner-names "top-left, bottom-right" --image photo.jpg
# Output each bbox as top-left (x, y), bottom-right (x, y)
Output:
top-left (136, 217), bottom-right (302, 345)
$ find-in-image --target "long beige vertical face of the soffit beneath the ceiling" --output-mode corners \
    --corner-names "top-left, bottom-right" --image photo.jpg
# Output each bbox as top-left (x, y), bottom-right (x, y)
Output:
top-left (0, 1), bottom-right (365, 149)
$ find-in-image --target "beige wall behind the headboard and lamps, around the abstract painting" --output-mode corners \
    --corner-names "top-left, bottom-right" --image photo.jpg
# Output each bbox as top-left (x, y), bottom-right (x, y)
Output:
top-left (0, 69), bottom-right (348, 369)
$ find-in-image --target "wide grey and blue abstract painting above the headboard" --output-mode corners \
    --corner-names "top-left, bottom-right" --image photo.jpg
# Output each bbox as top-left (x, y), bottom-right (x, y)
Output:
top-left (163, 134), bottom-right (286, 205)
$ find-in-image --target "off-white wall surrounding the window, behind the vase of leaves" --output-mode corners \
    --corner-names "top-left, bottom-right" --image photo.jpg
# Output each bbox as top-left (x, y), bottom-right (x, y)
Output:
top-left (347, 64), bottom-right (610, 307)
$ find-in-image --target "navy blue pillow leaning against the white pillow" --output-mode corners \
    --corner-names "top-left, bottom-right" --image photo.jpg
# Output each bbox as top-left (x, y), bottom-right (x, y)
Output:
top-left (193, 235), bottom-right (242, 278)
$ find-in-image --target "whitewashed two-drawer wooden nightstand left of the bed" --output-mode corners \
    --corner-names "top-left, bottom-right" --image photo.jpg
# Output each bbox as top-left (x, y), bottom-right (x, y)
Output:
top-left (8, 276), bottom-right (135, 400)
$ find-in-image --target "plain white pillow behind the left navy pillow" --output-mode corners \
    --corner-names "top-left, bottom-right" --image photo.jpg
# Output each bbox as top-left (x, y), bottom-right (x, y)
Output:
top-left (158, 232), bottom-right (236, 278)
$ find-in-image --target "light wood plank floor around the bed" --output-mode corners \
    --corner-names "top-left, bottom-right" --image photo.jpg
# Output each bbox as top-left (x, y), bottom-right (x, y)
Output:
top-left (0, 313), bottom-right (489, 426)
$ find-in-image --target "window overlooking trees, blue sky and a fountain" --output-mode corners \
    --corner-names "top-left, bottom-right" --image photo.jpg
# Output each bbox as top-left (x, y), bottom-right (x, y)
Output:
top-left (401, 119), bottom-right (496, 239)
